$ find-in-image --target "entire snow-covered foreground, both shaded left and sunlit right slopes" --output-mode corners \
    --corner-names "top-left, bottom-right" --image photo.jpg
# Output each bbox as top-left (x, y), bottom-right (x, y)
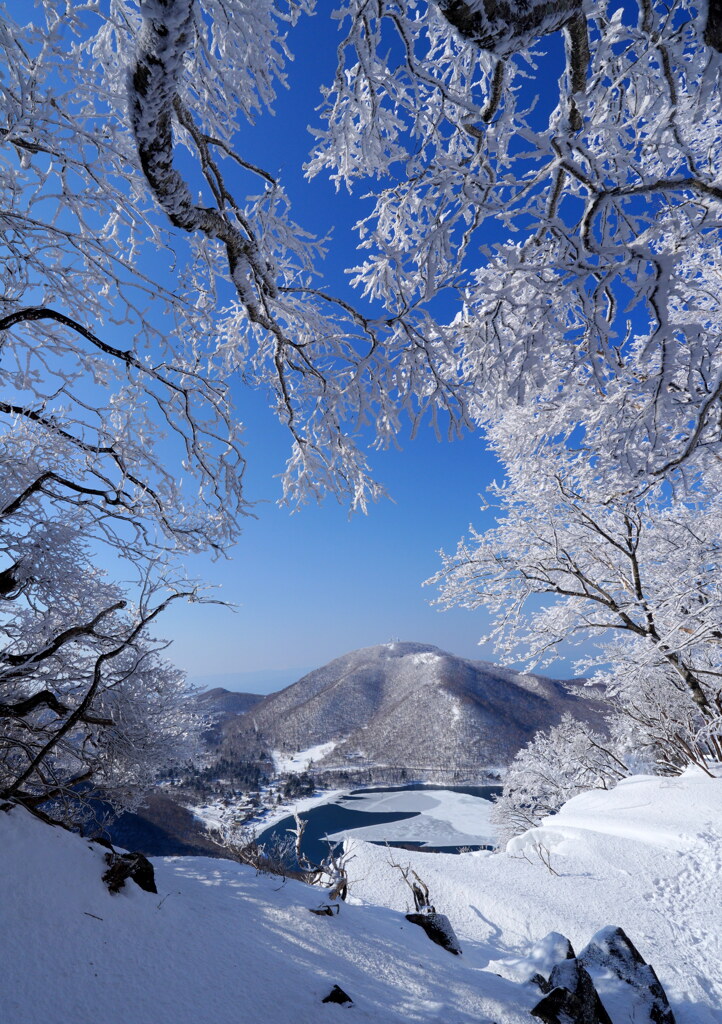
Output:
top-left (0, 771), bottom-right (722, 1024)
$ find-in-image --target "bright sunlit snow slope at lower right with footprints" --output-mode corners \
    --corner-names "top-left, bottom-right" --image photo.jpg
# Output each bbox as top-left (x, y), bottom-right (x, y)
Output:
top-left (348, 769), bottom-right (722, 1024)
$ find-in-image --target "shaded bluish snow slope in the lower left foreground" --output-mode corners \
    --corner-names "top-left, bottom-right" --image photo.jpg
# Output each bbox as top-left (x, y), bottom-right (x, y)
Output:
top-left (0, 810), bottom-right (527, 1024)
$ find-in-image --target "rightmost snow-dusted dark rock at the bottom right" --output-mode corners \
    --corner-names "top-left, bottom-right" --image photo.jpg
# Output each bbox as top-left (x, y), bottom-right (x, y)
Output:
top-left (579, 926), bottom-right (675, 1024)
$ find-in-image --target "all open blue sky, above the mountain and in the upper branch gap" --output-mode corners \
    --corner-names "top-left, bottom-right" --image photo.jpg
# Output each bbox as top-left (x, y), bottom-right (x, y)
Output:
top-left (161, 13), bottom-right (563, 691)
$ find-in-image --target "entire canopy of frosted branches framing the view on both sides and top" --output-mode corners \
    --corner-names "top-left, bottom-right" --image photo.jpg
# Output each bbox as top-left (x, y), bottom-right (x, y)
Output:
top-left (0, 0), bottom-right (722, 815)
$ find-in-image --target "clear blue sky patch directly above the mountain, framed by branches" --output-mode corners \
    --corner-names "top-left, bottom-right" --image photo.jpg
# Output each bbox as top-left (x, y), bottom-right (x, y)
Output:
top-left (162, 401), bottom-right (501, 688)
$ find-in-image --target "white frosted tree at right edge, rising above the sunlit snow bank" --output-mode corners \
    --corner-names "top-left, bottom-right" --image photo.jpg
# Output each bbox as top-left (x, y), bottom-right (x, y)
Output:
top-left (434, 453), bottom-right (722, 764)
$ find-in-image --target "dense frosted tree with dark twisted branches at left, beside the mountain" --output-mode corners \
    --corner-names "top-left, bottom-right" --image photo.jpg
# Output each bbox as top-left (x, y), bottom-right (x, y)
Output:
top-left (0, 522), bottom-right (201, 820)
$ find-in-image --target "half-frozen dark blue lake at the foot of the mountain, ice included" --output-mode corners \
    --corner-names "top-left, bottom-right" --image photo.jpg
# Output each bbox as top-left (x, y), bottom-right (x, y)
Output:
top-left (259, 785), bottom-right (501, 863)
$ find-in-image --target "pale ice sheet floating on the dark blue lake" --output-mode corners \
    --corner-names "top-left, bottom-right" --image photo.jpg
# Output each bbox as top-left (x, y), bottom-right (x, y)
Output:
top-left (329, 790), bottom-right (496, 848)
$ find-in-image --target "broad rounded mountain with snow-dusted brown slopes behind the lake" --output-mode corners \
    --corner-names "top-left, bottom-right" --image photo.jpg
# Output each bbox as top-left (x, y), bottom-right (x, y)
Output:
top-left (225, 642), bottom-right (600, 780)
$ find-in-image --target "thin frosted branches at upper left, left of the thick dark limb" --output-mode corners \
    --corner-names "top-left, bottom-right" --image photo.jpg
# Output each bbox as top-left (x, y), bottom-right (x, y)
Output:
top-left (0, 2), bottom-right (243, 550)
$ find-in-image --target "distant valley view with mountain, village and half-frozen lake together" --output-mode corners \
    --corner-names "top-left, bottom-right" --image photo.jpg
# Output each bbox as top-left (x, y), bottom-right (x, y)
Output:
top-left (108, 642), bottom-right (601, 860)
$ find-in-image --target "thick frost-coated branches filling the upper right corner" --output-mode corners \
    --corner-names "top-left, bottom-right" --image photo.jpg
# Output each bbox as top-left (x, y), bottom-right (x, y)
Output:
top-left (309, 0), bottom-right (722, 488)
